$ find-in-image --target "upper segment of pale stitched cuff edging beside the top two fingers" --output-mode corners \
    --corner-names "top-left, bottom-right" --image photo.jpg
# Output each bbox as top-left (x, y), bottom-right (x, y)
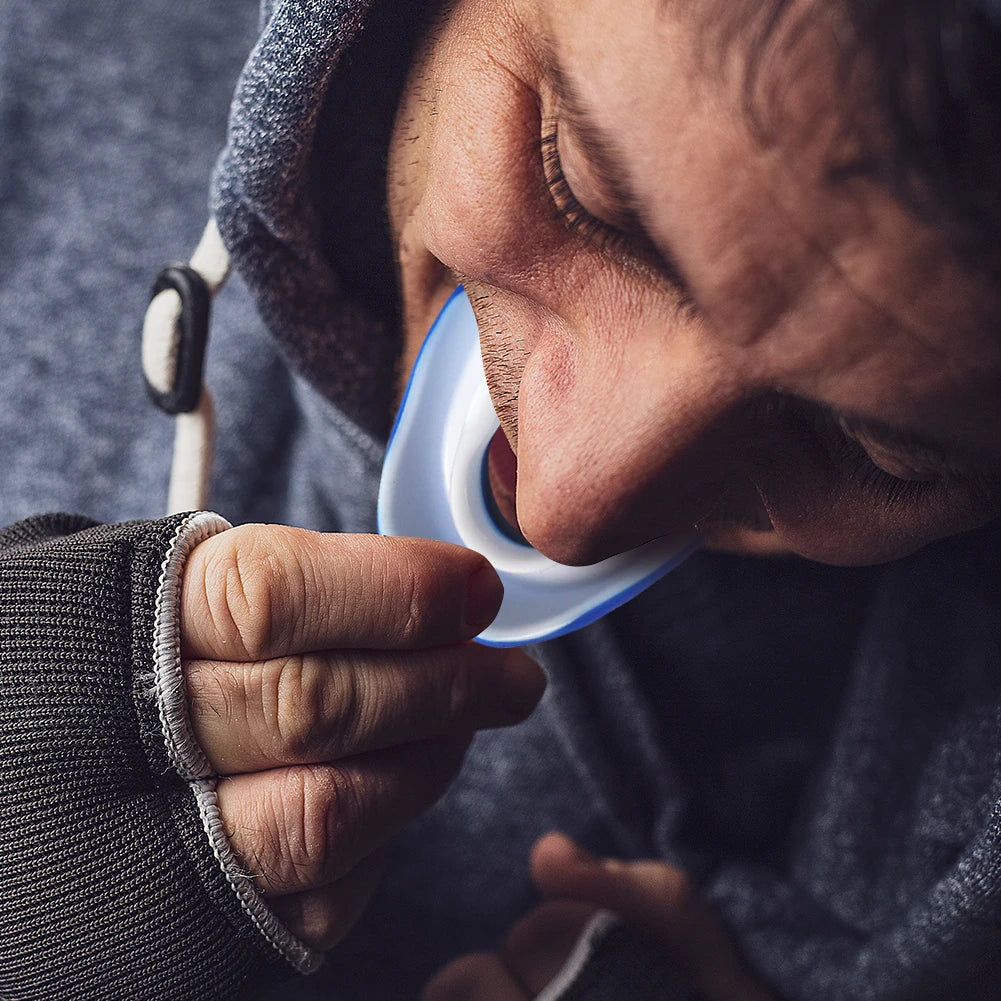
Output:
top-left (153, 512), bottom-right (232, 782)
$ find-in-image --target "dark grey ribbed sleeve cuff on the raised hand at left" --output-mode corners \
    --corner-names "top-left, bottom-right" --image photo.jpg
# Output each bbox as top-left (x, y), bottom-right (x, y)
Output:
top-left (0, 515), bottom-right (304, 1001)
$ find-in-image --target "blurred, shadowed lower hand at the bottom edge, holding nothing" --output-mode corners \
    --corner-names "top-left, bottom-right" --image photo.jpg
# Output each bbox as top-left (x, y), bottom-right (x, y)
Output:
top-left (421, 834), bottom-right (774, 1001)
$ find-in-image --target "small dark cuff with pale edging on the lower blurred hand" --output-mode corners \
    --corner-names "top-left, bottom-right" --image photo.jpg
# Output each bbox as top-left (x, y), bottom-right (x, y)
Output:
top-left (537, 912), bottom-right (699, 1001)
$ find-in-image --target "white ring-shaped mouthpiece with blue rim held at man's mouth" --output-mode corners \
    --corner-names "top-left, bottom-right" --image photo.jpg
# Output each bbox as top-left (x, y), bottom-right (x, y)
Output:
top-left (378, 288), bottom-right (697, 647)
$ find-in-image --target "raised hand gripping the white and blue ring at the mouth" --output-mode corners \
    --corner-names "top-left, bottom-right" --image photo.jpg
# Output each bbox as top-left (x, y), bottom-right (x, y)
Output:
top-left (181, 526), bottom-right (545, 949)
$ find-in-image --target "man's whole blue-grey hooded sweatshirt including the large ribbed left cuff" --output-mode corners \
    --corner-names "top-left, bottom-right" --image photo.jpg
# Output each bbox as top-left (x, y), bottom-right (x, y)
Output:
top-left (0, 0), bottom-right (1001, 1001)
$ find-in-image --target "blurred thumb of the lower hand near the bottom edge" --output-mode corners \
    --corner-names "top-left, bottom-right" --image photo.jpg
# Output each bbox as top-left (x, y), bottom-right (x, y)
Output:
top-left (532, 834), bottom-right (774, 1001)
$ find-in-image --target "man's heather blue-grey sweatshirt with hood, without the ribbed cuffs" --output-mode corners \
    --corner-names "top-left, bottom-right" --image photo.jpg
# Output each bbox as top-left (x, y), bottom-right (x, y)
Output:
top-left (0, 0), bottom-right (1001, 1001)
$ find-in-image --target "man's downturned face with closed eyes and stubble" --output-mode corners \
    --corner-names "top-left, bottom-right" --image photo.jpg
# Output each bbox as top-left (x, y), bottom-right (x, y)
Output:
top-left (389, 0), bottom-right (1001, 564)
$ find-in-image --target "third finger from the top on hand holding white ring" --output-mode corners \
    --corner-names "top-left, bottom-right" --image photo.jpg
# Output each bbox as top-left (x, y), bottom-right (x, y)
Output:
top-left (218, 738), bottom-right (468, 897)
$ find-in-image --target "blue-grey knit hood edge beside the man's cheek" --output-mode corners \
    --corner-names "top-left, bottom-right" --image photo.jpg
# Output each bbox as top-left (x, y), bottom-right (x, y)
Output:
top-left (211, 0), bottom-right (426, 437)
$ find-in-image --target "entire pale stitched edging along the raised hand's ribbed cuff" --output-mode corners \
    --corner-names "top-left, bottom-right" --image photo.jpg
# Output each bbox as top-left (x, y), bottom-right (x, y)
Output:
top-left (153, 512), bottom-right (323, 973)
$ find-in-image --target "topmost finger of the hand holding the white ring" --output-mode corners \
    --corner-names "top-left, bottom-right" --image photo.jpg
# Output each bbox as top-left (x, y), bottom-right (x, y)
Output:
top-left (181, 525), bottom-right (503, 661)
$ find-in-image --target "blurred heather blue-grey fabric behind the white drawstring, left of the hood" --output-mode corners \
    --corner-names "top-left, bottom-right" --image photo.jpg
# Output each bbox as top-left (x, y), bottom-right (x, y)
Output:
top-left (0, 0), bottom-right (368, 526)
